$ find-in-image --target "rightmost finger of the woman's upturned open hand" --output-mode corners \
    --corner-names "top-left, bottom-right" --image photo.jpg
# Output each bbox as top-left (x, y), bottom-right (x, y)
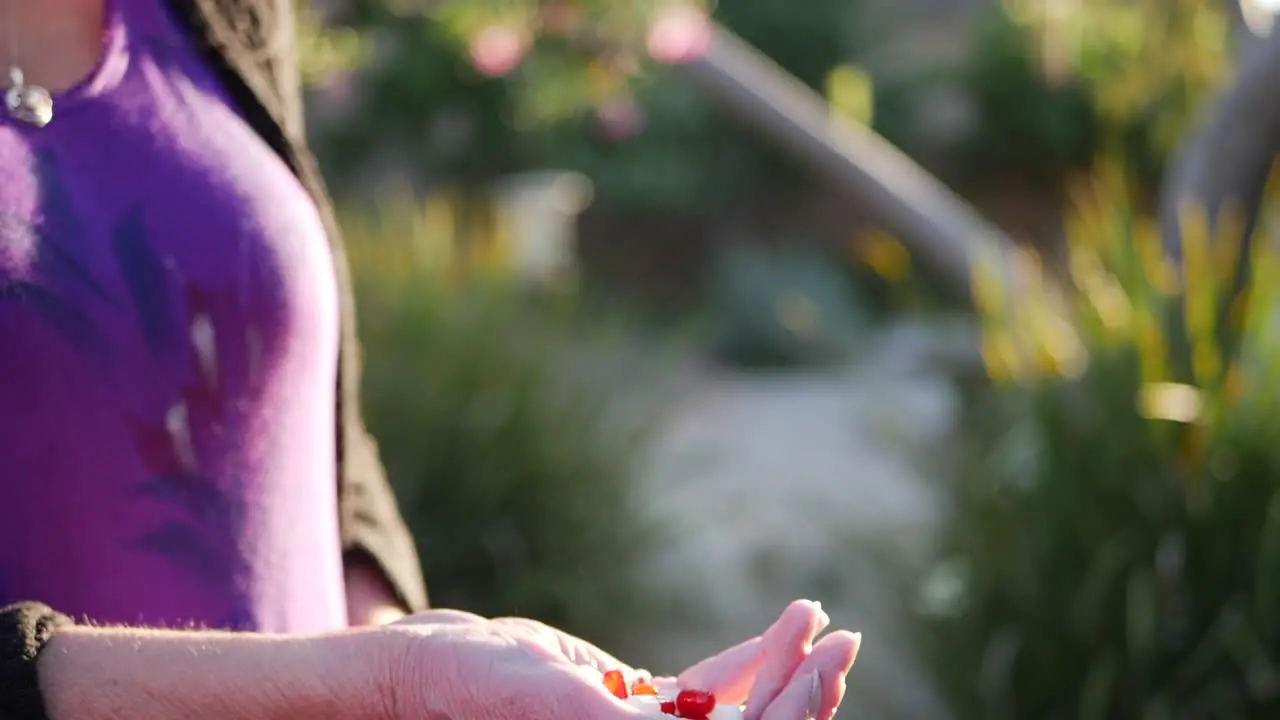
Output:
top-left (762, 630), bottom-right (861, 720)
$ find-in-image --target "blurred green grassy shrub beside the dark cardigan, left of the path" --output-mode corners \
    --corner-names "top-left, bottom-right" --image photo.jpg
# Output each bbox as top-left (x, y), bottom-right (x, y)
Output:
top-left (346, 197), bottom-right (664, 643)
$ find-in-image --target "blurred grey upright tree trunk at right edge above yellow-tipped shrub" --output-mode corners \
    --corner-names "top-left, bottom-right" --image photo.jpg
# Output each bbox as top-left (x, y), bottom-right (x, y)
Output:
top-left (1160, 7), bottom-right (1280, 258)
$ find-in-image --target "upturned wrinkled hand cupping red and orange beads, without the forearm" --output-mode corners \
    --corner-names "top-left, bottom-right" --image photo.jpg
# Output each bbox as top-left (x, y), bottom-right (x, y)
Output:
top-left (385, 601), bottom-right (860, 720)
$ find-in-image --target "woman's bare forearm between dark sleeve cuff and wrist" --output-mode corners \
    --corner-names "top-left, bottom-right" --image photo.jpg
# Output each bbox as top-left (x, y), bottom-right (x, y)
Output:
top-left (38, 628), bottom-right (385, 720)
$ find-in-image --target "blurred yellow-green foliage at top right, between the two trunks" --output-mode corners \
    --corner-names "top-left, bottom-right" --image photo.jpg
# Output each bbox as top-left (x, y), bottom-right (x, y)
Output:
top-left (961, 0), bottom-right (1233, 189)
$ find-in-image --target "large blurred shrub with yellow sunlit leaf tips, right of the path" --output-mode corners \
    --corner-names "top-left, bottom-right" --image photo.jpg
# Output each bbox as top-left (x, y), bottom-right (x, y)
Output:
top-left (920, 165), bottom-right (1280, 719)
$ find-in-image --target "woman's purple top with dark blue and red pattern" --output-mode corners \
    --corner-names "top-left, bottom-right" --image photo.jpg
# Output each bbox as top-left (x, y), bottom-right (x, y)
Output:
top-left (0, 0), bottom-right (347, 632)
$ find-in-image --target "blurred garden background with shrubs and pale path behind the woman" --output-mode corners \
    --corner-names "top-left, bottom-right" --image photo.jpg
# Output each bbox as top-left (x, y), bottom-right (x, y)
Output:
top-left (298, 0), bottom-right (1280, 720)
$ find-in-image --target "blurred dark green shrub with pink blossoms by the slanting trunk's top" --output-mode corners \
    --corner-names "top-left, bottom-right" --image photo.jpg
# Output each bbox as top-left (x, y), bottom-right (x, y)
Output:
top-left (307, 0), bottom-right (856, 213)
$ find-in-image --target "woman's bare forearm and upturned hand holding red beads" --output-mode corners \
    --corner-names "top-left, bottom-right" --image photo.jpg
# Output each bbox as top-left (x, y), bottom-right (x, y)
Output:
top-left (38, 601), bottom-right (859, 720)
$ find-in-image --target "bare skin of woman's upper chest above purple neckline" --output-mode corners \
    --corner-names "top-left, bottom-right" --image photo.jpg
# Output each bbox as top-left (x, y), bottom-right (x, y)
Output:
top-left (0, 0), bottom-right (104, 92)
